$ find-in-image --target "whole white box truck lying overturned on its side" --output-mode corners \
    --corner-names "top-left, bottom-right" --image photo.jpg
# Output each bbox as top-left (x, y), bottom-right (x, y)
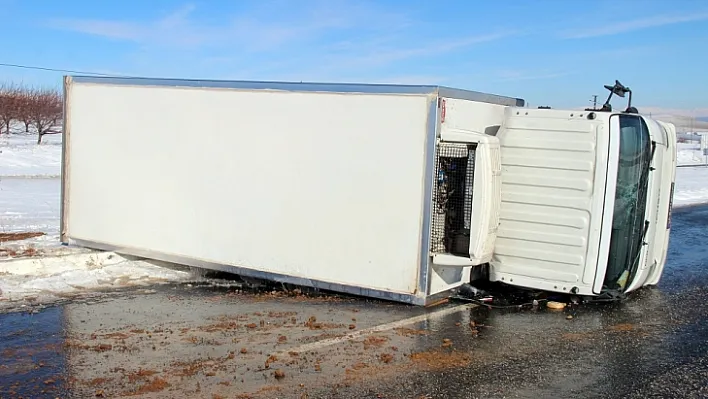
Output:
top-left (61, 76), bottom-right (676, 305)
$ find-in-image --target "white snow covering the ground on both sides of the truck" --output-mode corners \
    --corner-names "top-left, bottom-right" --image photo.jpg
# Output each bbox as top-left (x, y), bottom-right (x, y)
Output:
top-left (0, 135), bottom-right (708, 310)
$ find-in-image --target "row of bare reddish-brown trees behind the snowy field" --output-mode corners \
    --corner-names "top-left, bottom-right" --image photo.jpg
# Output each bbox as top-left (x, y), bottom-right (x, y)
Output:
top-left (0, 83), bottom-right (63, 144)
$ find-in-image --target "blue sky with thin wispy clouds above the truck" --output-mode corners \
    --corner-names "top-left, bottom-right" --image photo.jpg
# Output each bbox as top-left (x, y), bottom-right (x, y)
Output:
top-left (0, 0), bottom-right (708, 116)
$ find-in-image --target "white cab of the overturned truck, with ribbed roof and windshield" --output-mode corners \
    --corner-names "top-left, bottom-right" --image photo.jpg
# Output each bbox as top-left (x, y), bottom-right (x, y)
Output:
top-left (489, 97), bottom-right (676, 299)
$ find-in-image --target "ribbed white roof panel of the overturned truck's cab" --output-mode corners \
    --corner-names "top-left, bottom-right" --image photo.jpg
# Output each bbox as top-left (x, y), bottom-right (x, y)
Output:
top-left (489, 108), bottom-right (613, 295)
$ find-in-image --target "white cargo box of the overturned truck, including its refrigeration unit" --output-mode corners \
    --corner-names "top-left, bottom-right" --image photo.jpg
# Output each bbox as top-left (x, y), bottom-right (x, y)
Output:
top-left (61, 76), bottom-right (523, 305)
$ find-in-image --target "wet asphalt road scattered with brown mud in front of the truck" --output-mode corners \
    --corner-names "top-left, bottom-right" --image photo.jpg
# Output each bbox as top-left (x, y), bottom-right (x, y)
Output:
top-left (0, 206), bottom-right (708, 399)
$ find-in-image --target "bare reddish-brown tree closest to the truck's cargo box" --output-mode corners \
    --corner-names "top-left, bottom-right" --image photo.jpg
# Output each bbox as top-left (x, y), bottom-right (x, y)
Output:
top-left (25, 89), bottom-right (63, 144)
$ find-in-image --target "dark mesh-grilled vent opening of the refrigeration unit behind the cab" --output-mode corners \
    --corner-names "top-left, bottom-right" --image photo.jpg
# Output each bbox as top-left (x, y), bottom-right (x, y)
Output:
top-left (430, 143), bottom-right (476, 256)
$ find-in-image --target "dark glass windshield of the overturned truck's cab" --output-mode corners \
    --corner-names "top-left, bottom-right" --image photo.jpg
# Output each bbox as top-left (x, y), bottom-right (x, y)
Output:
top-left (603, 114), bottom-right (653, 292)
